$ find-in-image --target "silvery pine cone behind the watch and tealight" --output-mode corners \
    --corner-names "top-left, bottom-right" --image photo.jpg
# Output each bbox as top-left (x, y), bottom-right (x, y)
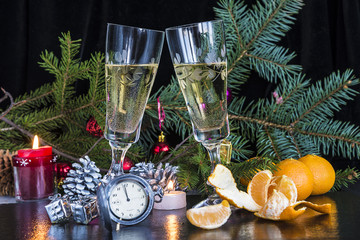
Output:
top-left (130, 162), bottom-right (179, 191)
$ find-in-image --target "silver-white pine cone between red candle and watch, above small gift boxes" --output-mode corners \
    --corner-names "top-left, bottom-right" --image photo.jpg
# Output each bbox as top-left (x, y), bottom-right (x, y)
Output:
top-left (62, 156), bottom-right (101, 201)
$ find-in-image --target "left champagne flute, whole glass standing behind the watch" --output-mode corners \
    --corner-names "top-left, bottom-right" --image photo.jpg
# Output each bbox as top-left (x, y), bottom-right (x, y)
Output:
top-left (103, 23), bottom-right (165, 183)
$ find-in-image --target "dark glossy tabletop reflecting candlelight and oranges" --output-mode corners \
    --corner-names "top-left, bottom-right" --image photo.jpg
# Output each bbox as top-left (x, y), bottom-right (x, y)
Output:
top-left (0, 191), bottom-right (360, 240)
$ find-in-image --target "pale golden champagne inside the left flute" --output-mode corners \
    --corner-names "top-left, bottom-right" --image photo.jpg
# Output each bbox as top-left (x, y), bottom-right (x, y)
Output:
top-left (105, 64), bottom-right (158, 140)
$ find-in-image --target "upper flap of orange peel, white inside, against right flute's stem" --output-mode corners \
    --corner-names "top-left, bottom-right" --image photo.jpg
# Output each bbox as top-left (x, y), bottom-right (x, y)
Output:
top-left (208, 164), bottom-right (236, 188)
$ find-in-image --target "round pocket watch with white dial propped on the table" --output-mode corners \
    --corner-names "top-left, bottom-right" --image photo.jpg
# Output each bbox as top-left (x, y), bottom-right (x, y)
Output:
top-left (97, 174), bottom-right (163, 231)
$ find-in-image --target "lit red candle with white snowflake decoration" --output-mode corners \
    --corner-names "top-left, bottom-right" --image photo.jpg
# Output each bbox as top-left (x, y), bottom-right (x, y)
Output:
top-left (13, 136), bottom-right (55, 200)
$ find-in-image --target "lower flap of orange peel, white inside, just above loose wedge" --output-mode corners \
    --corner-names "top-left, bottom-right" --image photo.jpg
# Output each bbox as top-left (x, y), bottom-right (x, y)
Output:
top-left (216, 187), bottom-right (261, 212)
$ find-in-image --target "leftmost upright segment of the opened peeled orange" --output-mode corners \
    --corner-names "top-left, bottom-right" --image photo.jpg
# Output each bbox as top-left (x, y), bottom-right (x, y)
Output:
top-left (247, 170), bottom-right (272, 206)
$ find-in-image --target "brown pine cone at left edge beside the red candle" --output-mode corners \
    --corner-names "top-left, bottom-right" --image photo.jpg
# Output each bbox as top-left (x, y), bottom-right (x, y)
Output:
top-left (0, 150), bottom-right (16, 196)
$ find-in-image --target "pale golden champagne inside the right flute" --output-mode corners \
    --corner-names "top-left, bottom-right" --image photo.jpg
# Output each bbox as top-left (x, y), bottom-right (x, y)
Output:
top-left (174, 62), bottom-right (227, 132)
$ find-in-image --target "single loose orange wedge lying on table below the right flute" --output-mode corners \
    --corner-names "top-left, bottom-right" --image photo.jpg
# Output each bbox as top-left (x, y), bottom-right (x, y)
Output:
top-left (186, 200), bottom-right (231, 229)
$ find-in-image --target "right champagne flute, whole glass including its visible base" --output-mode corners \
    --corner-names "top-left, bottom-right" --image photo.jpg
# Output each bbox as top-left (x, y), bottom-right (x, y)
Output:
top-left (166, 20), bottom-right (230, 207)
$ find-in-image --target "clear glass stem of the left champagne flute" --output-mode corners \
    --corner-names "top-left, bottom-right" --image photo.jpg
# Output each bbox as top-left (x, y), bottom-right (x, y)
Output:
top-left (103, 141), bottom-right (131, 182)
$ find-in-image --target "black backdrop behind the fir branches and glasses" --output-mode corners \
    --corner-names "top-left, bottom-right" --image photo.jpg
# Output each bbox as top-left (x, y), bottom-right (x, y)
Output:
top-left (0, 0), bottom-right (360, 163)
